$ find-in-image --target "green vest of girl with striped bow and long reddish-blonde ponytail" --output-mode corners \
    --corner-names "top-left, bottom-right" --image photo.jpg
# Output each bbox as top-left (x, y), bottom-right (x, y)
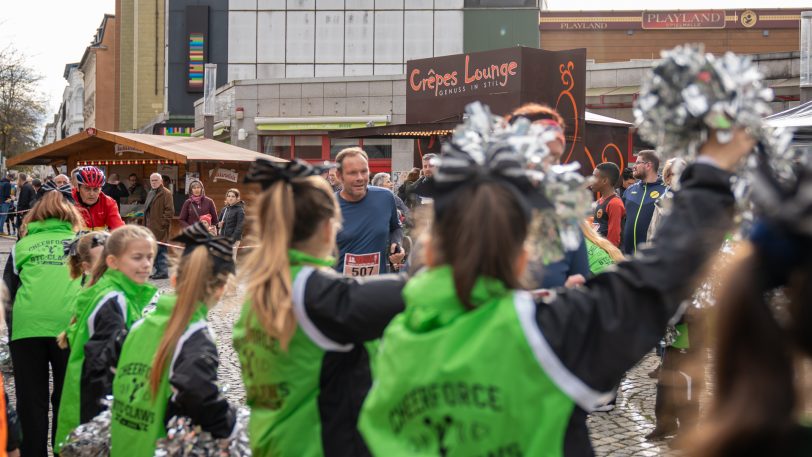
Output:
top-left (110, 295), bottom-right (208, 457)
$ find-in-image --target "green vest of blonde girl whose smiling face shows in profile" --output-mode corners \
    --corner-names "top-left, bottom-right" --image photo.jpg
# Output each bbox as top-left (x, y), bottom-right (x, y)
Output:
top-left (54, 270), bottom-right (158, 453)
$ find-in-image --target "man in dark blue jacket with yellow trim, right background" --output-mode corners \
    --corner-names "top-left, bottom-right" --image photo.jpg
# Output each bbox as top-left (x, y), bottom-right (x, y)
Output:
top-left (622, 150), bottom-right (666, 255)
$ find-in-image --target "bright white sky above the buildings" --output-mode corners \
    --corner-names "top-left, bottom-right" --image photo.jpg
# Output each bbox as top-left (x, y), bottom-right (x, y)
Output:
top-left (0, 0), bottom-right (812, 128)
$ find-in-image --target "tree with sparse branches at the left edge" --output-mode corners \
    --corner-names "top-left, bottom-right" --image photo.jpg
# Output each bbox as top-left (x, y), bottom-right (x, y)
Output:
top-left (0, 46), bottom-right (47, 158)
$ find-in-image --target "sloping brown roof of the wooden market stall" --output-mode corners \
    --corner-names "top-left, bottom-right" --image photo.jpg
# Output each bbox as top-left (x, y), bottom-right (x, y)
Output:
top-left (6, 129), bottom-right (284, 167)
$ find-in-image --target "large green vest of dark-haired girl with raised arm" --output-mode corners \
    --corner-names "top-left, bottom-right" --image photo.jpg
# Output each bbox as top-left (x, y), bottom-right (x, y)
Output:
top-left (359, 266), bottom-right (575, 457)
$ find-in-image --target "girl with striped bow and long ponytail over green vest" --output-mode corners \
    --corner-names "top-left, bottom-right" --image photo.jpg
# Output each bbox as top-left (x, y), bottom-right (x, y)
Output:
top-left (110, 222), bottom-right (235, 457)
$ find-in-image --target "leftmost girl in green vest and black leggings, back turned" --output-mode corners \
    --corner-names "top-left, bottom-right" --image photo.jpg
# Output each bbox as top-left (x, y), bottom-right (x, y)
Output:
top-left (7, 191), bottom-right (82, 457)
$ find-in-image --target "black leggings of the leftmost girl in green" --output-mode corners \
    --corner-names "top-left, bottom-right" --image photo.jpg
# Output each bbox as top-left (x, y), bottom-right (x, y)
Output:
top-left (9, 336), bottom-right (70, 457)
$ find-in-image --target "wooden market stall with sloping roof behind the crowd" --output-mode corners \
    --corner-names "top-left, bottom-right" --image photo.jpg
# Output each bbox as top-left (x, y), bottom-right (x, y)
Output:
top-left (6, 128), bottom-right (284, 232)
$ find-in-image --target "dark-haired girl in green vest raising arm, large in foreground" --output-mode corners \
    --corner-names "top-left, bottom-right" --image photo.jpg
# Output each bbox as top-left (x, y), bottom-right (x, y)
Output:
top-left (360, 116), bottom-right (753, 457)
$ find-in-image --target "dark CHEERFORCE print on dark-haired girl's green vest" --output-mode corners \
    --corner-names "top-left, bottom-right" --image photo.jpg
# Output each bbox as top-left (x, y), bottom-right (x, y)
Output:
top-left (388, 381), bottom-right (522, 457)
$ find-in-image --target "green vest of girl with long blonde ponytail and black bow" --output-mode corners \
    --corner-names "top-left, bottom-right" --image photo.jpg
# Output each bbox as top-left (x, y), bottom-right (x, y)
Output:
top-left (233, 250), bottom-right (340, 457)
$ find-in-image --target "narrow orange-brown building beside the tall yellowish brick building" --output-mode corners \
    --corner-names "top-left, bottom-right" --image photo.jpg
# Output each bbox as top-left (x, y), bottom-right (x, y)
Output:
top-left (79, 14), bottom-right (119, 131)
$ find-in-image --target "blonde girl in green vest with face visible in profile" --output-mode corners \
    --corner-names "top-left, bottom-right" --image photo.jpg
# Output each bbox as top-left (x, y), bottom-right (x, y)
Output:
top-left (56, 225), bottom-right (157, 452)
